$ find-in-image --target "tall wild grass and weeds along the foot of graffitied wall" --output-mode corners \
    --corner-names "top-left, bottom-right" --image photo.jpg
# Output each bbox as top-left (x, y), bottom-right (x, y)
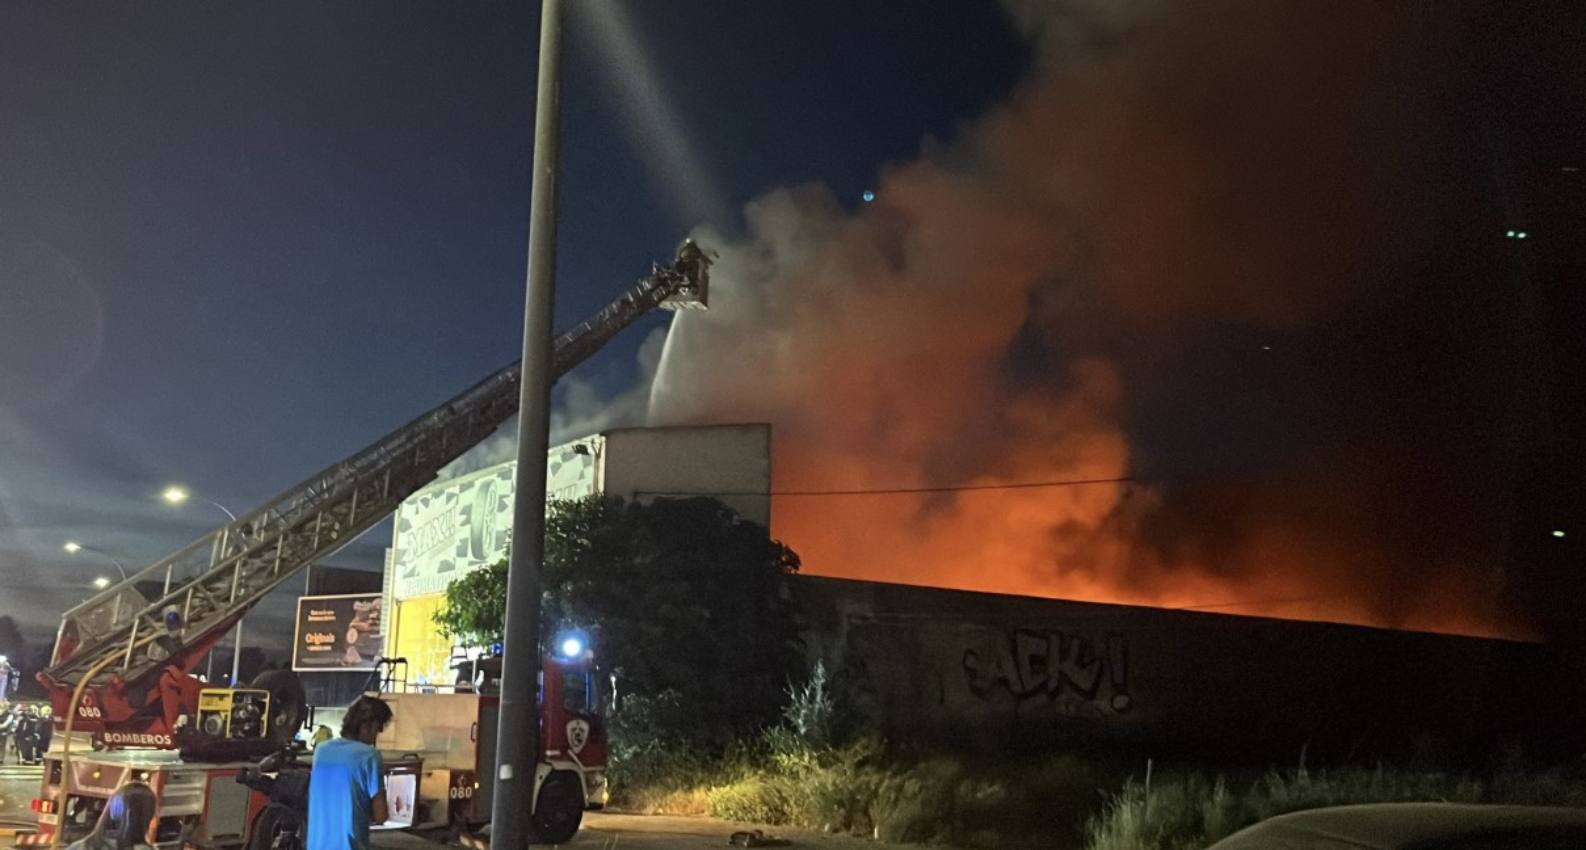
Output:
top-left (611, 666), bottom-right (1586, 850)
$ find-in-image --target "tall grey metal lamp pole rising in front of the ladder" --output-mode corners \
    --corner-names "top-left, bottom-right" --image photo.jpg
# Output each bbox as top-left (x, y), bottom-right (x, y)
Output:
top-left (490, 0), bottom-right (561, 850)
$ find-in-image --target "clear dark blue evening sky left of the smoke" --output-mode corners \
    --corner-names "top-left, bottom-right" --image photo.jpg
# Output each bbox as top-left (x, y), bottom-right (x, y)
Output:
top-left (0, 0), bottom-right (1028, 633)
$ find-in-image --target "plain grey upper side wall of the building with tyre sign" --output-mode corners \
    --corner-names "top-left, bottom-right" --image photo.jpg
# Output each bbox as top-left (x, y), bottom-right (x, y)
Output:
top-left (598, 423), bottom-right (771, 526)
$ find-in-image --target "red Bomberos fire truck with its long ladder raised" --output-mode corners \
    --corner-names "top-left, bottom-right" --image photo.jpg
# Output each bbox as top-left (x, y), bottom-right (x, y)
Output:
top-left (24, 241), bottom-right (711, 850)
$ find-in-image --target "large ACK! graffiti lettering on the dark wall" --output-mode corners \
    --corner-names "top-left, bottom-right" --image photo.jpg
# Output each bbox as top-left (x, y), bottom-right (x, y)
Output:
top-left (963, 630), bottom-right (1134, 717)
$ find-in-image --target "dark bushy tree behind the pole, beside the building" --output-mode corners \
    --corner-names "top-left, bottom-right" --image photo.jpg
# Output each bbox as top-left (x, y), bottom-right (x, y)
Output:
top-left (436, 496), bottom-right (803, 742)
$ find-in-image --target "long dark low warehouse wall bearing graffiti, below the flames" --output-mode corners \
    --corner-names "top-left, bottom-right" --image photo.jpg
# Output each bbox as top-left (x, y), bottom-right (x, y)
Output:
top-left (795, 577), bottom-right (1546, 758)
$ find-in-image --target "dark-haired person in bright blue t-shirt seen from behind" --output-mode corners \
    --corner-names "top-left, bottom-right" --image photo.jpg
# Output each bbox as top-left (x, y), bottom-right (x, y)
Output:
top-left (306, 696), bottom-right (392, 850)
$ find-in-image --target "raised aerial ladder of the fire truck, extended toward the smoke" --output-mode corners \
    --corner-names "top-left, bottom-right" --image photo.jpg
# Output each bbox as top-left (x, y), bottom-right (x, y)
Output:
top-left (38, 241), bottom-right (711, 749)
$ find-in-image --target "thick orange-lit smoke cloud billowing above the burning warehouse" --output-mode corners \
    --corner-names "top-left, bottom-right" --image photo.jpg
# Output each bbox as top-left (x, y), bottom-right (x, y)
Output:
top-left (650, 0), bottom-right (1526, 634)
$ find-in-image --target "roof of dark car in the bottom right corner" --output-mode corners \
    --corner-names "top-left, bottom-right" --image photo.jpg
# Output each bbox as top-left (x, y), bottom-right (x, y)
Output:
top-left (1207, 802), bottom-right (1586, 850)
